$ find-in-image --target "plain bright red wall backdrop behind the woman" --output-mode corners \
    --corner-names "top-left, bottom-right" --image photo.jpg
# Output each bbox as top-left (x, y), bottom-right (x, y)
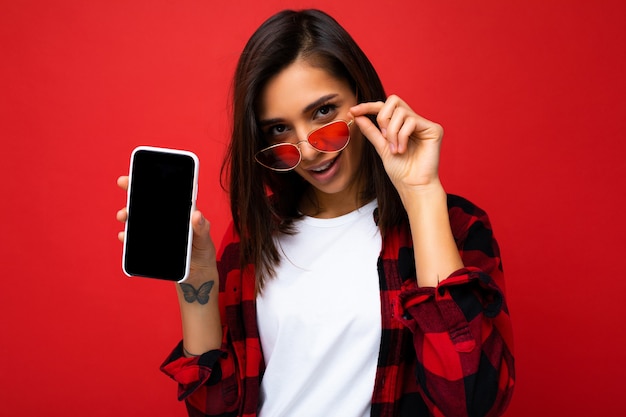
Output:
top-left (0, 0), bottom-right (626, 417)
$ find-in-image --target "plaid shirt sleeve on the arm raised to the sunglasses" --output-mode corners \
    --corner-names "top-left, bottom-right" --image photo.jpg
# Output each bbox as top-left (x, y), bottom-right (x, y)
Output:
top-left (396, 196), bottom-right (515, 417)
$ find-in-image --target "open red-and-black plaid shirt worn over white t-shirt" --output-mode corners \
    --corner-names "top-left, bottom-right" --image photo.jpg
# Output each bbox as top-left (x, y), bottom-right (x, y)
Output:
top-left (161, 195), bottom-right (515, 417)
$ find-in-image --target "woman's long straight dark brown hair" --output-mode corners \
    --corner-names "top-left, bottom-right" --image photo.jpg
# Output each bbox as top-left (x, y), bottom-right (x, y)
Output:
top-left (222, 10), bottom-right (406, 291)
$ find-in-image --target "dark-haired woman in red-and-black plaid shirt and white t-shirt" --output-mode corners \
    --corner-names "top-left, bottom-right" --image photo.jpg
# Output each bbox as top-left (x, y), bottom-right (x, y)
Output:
top-left (118, 10), bottom-right (514, 416)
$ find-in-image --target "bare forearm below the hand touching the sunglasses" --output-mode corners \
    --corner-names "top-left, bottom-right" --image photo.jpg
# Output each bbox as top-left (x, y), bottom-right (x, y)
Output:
top-left (400, 183), bottom-right (463, 287)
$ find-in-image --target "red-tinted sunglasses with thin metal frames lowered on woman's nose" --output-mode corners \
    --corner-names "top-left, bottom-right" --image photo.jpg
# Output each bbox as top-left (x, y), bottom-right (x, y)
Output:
top-left (254, 120), bottom-right (353, 172)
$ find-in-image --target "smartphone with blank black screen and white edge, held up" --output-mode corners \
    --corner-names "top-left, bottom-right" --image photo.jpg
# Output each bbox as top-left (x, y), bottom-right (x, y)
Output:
top-left (122, 146), bottom-right (199, 282)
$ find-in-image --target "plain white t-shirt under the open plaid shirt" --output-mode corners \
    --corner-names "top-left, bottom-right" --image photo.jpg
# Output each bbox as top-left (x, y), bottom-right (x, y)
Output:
top-left (257, 201), bottom-right (382, 417)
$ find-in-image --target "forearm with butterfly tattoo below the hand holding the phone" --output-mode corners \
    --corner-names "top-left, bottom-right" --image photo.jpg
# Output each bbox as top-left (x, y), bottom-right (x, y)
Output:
top-left (176, 269), bottom-right (222, 356)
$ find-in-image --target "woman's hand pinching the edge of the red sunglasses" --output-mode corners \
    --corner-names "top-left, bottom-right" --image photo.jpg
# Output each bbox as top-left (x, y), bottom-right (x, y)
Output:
top-left (350, 95), bottom-right (443, 194)
